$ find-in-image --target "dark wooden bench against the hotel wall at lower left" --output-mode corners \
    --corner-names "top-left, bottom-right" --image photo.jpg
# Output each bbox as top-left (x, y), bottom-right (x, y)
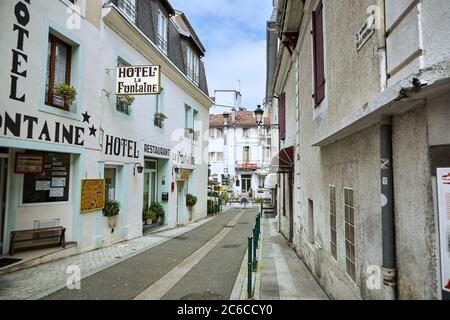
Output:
top-left (9, 227), bottom-right (66, 256)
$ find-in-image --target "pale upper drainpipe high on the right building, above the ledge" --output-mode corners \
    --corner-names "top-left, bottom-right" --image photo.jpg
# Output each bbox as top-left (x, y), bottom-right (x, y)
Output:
top-left (375, 0), bottom-right (388, 91)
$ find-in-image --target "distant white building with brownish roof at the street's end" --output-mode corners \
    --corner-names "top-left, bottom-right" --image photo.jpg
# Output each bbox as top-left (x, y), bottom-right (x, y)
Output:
top-left (209, 109), bottom-right (271, 198)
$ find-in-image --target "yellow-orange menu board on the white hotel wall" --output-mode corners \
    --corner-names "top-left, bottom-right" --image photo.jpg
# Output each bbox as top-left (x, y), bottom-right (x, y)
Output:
top-left (80, 179), bottom-right (105, 213)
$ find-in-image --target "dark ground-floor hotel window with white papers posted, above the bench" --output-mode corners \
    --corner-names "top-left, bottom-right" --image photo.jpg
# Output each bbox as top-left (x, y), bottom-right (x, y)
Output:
top-left (22, 151), bottom-right (71, 203)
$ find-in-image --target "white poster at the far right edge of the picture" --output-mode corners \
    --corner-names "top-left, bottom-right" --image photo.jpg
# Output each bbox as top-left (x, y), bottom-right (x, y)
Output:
top-left (437, 168), bottom-right (450, 292)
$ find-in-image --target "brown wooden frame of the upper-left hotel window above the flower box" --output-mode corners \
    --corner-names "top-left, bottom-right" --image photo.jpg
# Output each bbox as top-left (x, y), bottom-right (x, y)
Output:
top-left (45, 33), bottom-right (73, 111)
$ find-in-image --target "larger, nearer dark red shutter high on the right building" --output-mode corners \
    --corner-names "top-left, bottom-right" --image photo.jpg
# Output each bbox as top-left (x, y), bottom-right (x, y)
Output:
top-left (313, 1), bottom-right (325, 106)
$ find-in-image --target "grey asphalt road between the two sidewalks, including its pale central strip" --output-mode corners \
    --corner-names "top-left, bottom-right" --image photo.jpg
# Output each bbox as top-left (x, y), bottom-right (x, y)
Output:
top-left (44, 209), bottom-right (257, 300)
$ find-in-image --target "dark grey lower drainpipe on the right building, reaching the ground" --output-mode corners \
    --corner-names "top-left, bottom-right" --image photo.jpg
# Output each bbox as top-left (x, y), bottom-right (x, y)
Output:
top-left (380, 117), bottom-right (397, 300)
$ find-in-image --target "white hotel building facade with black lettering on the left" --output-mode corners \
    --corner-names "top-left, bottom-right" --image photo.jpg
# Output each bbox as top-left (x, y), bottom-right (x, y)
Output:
top-left (0, 0), bottom-right (212, 253)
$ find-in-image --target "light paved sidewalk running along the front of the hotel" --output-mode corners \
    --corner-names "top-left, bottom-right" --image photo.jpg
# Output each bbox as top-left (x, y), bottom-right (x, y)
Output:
top-left (0, 217), bottom-right (213, 300)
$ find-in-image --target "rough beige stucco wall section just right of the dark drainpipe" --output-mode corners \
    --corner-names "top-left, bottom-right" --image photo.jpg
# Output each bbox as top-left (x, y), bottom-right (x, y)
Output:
top-left (392, 107), bottom-right (437, 299)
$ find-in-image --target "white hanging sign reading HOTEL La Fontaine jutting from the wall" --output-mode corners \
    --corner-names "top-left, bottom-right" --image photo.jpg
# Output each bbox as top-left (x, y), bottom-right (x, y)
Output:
top-left (116, 66), bottom-right (161, 96)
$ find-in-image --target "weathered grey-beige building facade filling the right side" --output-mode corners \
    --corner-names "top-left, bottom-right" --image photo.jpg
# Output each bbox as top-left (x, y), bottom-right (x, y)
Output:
top-left (272, 0), bottom-right (450, 299)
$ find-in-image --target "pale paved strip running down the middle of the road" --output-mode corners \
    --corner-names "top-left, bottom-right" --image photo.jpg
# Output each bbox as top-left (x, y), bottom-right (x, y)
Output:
top-left (134, 211), bottom-right (245, 300)
